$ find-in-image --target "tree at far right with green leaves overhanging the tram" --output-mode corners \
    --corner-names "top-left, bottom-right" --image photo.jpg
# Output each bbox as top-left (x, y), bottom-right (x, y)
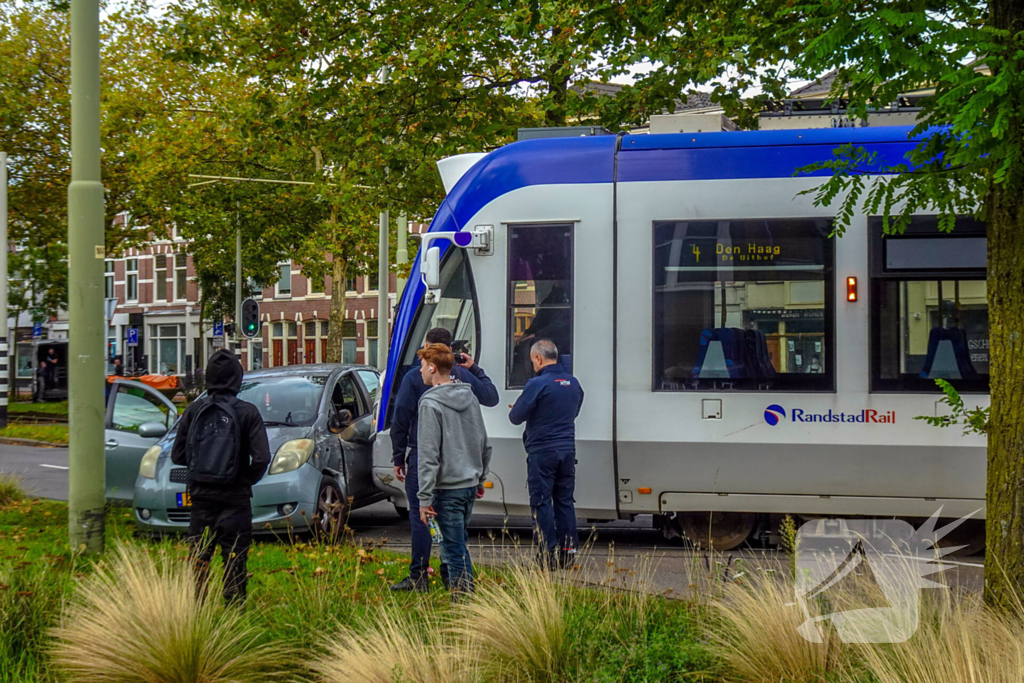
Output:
top-left (627, 0), bottom-right (1024, 606)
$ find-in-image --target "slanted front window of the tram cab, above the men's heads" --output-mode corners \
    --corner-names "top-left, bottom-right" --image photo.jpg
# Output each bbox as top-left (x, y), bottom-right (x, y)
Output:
top-left (385, 249), bottom-right (479, 426)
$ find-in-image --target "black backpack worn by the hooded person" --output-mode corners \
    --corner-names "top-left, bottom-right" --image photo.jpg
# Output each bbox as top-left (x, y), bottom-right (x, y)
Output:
top-left (187, 397), bottom-right (242, 484)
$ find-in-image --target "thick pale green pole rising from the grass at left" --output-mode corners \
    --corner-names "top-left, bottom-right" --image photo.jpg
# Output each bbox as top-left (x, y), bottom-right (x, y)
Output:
top-left (68, 0), bottom-right (106, 553)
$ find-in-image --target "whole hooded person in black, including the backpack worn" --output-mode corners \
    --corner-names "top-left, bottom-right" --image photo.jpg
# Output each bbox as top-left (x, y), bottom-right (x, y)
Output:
top-left (171, 349), bottom-right (270, 603)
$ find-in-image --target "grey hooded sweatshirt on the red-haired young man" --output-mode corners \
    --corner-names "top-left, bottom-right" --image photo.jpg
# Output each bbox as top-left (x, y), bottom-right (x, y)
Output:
top-left (417, 382), bottom-right (490, 507)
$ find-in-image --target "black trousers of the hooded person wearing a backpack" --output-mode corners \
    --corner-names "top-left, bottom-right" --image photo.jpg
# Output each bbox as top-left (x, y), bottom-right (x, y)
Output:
top-left (188, 500), bottom-right (253, 603)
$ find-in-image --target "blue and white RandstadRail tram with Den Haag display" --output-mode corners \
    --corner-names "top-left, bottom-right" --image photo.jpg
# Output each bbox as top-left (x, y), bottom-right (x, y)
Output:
top-left (375, 127), bottom-right (988, 548)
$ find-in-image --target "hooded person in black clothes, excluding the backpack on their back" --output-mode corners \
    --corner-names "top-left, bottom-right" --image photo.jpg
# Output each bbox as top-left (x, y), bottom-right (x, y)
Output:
top-left (171, 349), bottom-right (270, 603)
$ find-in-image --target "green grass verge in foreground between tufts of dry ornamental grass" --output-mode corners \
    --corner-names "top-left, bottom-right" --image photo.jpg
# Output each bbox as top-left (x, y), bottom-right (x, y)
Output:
top-left (0, 501), bottom-right (716, 683)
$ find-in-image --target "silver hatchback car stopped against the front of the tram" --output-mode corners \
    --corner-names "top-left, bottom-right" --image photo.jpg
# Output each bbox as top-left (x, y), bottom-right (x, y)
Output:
top-left (128, 365), bottom-right (386, 535)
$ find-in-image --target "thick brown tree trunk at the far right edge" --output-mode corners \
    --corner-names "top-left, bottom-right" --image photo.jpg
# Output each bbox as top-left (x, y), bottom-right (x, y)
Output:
top-left (985, 0), bottom-right (1024, 609)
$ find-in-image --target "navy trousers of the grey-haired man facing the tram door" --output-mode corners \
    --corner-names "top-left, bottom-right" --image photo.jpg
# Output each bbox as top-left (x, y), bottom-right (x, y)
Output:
top-left (526, 450), bottom-right (580, 553)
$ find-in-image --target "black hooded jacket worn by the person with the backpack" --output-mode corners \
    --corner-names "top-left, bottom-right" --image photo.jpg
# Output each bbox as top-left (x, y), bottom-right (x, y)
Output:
top-left (171, 349), bottom-right (270, 505)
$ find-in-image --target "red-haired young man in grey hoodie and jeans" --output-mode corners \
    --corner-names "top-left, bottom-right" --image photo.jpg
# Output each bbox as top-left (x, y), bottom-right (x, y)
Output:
top-left (418, 344), bottom-right (490, 598)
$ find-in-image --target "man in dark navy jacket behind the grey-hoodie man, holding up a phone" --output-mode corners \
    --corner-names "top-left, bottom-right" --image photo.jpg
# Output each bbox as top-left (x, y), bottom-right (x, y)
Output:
top-left (391, 328), bottom-right (499, 591)
